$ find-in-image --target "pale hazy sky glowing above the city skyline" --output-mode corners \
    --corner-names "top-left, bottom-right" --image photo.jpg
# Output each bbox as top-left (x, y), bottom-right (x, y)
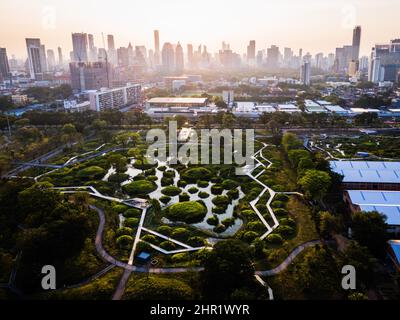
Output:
top-left (0, 0), bottom-right (400, 57)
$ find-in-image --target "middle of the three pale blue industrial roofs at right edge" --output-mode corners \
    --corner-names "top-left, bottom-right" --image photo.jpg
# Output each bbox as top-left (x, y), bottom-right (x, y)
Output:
top-left (347, 190), bottom-right (400, 225)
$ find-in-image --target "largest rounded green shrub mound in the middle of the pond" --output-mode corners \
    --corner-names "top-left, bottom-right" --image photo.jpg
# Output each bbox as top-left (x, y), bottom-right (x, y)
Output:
top-left (167, 201), bottom-right (207, 223)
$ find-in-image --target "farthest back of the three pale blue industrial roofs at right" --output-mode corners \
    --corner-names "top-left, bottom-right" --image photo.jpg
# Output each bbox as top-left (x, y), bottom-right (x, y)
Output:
top-left (330, 161), bottom-right (400, 183)
